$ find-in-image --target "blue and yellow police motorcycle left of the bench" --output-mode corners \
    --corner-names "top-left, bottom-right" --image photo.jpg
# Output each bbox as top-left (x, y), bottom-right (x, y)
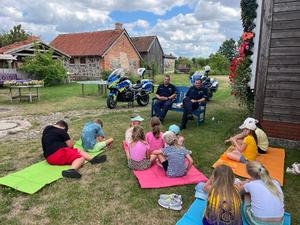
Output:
top-left (106, 68), bottom-right (153, 109)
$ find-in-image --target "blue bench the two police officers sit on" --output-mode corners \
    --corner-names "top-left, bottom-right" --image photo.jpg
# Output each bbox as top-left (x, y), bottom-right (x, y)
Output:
top-left (151, 86), bottom-right (206, 126)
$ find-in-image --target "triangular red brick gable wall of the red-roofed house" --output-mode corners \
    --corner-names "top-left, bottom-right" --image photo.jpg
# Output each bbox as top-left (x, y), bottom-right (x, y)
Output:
top-left (101, 34), bottom-right (140, 73)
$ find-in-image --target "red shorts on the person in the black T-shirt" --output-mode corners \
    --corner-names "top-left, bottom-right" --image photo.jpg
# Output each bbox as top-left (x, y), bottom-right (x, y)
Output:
top-left (46, 147), bottom-right (82, 165)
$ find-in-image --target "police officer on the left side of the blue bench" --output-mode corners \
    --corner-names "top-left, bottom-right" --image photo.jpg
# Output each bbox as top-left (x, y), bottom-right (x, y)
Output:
top-left (153, 75), bottom-right (176, 122)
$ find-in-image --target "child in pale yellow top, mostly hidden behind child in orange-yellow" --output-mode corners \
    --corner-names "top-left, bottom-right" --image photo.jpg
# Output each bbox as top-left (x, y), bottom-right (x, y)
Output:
top-left (225, 117), bottom-right (269, 154)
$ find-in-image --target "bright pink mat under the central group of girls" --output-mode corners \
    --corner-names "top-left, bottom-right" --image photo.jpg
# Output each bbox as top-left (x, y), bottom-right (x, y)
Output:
top-left (123, 142), bottom-right (207, 188)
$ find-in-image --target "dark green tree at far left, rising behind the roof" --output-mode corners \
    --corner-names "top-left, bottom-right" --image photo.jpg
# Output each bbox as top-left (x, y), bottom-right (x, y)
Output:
top-left (0, 24), bottom-right (31, 47)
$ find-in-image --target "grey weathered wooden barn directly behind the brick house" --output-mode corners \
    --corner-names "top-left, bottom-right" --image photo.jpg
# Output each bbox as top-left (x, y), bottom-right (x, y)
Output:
top-left (131, 36), bottom-right (164, 73)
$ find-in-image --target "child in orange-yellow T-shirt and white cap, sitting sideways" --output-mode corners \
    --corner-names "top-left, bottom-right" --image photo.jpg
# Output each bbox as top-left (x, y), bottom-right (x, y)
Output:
top-left (226, 120), bottom-right (257, 163)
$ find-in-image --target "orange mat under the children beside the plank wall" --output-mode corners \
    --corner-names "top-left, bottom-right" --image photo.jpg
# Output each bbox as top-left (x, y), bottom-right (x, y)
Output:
top-left (213, 147), bottom-right (285, 186)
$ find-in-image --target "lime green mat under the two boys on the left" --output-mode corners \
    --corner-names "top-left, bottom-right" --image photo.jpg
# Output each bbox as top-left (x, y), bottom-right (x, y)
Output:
top-left (0, 141), bottom-right (104, 194)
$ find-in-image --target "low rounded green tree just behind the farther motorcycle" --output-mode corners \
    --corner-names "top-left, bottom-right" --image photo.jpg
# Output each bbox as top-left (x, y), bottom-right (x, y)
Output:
top-left (208, 53), bottom-right (230, 75)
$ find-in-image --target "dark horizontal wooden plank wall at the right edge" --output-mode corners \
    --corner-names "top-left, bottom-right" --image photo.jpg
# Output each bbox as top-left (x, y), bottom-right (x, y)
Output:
top-left (262, 0), bottom-right (300, 123)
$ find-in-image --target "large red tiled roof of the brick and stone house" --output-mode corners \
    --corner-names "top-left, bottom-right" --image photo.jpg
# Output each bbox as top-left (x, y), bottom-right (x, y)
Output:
top-left (50, 30), bottom-right (124, 56)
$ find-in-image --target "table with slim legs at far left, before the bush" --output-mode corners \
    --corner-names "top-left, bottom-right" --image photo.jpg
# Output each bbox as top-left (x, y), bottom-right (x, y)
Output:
top-left (8, 85), bottom-right (44, 103)
